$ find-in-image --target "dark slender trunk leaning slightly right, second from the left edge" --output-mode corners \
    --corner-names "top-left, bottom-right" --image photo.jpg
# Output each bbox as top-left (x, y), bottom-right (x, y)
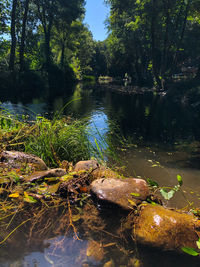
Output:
top-left (20, 0), bottom-right (30, 71)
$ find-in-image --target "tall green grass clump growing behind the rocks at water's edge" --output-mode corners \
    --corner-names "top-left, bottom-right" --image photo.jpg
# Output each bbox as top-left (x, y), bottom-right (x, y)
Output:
top-left (25, 117), bottom-right (92, 166)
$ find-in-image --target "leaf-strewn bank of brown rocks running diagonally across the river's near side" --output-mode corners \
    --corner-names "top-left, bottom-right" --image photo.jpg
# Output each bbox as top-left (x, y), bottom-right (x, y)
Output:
top-left (0, 151), bottom-right (200, 262)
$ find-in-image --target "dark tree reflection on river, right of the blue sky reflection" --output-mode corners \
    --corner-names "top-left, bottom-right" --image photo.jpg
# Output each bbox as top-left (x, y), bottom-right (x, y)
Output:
top-left (106, 92), bottom-right (200, 146)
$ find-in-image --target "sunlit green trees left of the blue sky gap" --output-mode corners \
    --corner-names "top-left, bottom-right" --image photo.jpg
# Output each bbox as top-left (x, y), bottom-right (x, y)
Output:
top-left (0, 0), bottom-right (98, 86)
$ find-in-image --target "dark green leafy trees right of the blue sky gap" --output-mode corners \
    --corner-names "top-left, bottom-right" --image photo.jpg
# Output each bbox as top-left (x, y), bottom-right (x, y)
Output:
top-left (105, 0), bottom-right (200, 87)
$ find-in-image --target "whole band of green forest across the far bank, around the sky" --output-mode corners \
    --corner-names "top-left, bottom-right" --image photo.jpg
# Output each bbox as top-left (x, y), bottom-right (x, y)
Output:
top-left (0, 0), bottom-right (200, 89)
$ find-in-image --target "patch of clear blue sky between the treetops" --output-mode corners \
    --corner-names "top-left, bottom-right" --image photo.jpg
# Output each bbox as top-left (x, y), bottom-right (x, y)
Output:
top-left (84, 0), bottom-right (109, 41)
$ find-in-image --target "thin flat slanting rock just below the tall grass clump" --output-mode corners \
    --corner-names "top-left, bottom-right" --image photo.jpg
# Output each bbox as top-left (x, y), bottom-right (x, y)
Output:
top-left (25, 168), bottom-right (67, 182)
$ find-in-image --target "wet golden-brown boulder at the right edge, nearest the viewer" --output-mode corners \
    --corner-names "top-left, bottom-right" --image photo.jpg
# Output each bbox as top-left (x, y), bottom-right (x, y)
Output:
top-left (133, 204), bottom-right (200, 252)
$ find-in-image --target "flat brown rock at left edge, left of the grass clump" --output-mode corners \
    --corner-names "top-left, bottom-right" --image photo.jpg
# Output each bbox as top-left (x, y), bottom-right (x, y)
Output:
top-left (0, 151), bottom-right (47, 171)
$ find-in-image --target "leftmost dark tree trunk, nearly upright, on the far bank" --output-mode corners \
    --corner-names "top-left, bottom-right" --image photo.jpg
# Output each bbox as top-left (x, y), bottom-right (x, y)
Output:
top-left (9, 0), bottom-right (17, 71)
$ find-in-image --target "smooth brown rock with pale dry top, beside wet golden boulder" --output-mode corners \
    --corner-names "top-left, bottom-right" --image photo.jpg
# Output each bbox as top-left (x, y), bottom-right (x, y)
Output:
top-left (91, 178), bottom-right (150, 210)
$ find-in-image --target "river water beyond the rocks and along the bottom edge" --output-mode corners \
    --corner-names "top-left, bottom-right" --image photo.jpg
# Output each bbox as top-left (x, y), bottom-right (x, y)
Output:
top-left (0, 84), bottom-right (200, 267)
